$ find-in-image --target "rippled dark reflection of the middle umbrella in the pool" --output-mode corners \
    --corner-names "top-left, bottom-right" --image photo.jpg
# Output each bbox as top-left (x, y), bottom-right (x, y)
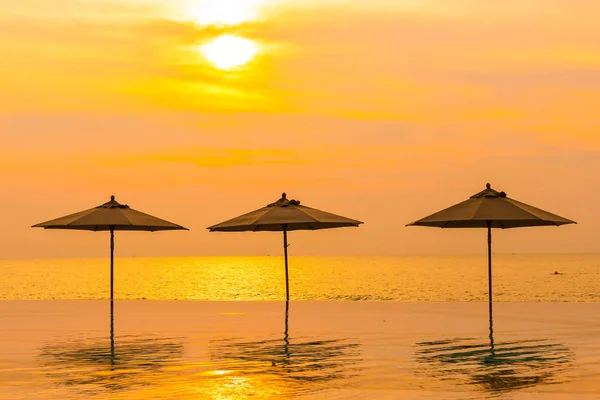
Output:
top-left (210, 302), bottom-right (362, 391)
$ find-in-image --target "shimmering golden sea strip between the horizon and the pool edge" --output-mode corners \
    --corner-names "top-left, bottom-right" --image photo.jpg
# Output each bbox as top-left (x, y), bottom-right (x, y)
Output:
top-left (0, 254), bottom-right (600, 302)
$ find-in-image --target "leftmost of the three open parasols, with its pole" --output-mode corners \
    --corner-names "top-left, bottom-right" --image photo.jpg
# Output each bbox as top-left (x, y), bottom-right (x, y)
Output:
top-left (33, 196), bottom-right (187, 300)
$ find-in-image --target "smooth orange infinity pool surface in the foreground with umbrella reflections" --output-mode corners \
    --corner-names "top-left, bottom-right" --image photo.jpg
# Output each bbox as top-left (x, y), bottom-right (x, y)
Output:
top-left (0, 300), bottom-right (600, 400)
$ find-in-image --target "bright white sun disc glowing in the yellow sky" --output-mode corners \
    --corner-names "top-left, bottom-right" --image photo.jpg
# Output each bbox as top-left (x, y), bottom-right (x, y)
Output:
top-left (200, 35), bottom-right (258, 70)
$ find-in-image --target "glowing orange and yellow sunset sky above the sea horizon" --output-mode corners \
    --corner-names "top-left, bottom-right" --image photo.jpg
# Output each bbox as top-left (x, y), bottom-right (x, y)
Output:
top-left (0, 0), bottom-right (600, 258)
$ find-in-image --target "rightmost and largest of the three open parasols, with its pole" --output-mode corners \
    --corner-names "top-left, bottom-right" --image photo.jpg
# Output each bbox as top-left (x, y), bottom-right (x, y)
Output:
top-left (407, 183), bottom-right (576, 302)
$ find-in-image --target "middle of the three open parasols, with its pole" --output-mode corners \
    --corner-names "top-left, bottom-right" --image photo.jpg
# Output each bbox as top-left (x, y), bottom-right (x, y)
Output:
top-left (207, 193), bottom-right (362, 300)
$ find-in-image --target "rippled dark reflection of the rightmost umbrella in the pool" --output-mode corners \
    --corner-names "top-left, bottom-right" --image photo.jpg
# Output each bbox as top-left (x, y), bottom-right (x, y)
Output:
top-left (416, 303), bottom-right (575, 394)
